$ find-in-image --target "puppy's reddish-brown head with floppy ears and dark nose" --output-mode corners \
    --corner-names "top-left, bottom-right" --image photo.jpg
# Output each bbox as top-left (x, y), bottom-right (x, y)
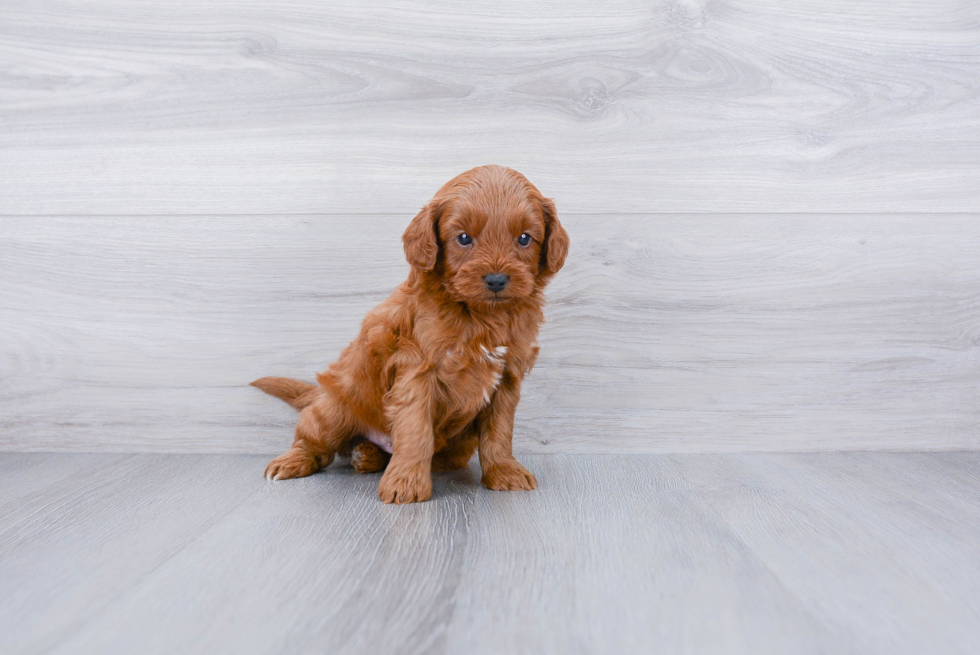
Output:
top-left (402, 166), bottom-right (568, 311)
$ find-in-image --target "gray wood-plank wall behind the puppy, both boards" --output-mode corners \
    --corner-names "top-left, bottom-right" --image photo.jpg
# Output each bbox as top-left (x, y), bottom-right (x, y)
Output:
top-left (0, 0), bottom-right (980, 452)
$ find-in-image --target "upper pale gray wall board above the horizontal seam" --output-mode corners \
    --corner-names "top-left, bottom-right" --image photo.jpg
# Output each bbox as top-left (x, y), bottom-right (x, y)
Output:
top-left (0, 0), bottom-right (980, 215)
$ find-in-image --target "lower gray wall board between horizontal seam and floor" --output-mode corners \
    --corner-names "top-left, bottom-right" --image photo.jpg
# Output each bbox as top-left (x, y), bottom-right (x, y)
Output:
top-left (0, 215), bottom-right (980, 453)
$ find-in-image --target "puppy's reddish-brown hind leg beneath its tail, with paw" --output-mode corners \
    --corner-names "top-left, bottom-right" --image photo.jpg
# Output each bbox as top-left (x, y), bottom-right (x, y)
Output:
top-left (265, 394), bottom-right (353, 480)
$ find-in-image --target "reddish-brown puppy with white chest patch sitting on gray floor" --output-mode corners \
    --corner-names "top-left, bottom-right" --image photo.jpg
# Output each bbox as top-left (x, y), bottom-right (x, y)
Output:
top-left (252, 166), bottom-right (569, 504)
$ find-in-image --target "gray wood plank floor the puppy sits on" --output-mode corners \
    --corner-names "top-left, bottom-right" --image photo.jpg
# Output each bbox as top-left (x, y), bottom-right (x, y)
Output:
top-left (0, 452), bottom-right (980, 655)
